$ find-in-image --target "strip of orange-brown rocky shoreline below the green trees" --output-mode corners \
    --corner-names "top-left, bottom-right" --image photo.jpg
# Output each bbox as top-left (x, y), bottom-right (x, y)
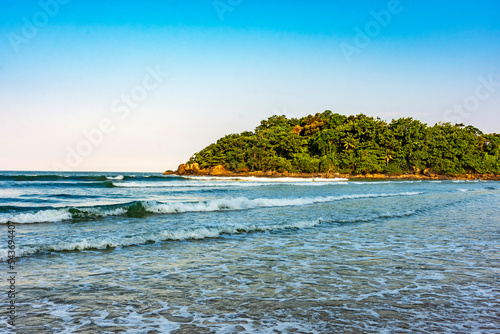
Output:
top-left (163, 163), bottom-right (500, 181)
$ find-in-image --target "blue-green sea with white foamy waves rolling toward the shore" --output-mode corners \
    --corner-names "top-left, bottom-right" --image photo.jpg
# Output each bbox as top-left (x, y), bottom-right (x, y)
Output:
top-left (0, 172), bottom-right (500, 333)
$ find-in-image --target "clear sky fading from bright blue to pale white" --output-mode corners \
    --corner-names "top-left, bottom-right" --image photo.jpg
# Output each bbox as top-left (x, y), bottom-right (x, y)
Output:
top-left (0, 0), bottom-right (500, 172)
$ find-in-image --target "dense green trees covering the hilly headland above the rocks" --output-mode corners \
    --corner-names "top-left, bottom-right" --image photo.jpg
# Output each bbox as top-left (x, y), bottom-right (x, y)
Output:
top-left (189, 110), bottom-right (500, 175)
